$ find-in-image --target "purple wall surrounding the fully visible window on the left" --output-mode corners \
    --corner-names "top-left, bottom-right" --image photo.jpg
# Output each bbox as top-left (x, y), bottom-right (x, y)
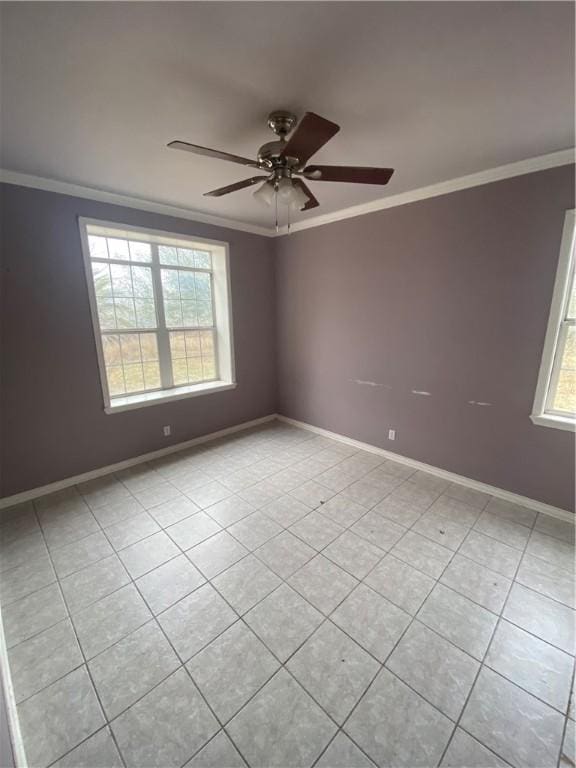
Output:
top-left (0, 184), bottom-right (276, 496)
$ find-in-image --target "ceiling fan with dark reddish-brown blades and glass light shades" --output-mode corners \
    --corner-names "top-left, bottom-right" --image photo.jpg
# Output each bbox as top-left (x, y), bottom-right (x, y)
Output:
top-left (168, 110), bottom-right (394, 219)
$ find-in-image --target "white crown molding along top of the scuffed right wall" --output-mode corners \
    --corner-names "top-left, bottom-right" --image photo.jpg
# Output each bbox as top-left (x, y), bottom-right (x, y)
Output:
top-left (278, 148), bottom-right (576, 236)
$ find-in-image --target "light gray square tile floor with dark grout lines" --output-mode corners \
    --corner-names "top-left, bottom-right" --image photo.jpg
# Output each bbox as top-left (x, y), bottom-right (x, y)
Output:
top-left (0, 423), bottom-right (575, 768)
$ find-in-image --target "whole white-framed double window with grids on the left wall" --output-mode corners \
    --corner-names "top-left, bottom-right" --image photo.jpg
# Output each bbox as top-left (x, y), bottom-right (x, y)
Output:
top-left (80, 219), bottom-right (235, 413)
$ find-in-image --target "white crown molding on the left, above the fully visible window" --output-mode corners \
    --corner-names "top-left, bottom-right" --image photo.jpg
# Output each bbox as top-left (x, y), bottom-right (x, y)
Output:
top-left (0, 168), bottom-right (276, 237)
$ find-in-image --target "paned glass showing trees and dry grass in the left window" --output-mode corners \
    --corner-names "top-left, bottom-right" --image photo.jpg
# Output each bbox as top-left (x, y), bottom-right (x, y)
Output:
top-left (87, 226), bottom-right (218, 397)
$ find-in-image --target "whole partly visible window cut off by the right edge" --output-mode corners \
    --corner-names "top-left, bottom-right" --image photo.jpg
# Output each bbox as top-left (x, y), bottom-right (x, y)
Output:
top-left (530, 211), bottom-right (576, 430)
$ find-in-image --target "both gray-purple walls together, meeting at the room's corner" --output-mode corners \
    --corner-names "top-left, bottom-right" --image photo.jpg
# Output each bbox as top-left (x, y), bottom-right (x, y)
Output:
top-left (0, 167), bottom-right (575, 509)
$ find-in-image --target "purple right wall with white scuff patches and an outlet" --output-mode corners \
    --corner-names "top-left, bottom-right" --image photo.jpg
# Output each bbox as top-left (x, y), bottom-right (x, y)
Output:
top-left (276, 167), bottom-right (574, 509)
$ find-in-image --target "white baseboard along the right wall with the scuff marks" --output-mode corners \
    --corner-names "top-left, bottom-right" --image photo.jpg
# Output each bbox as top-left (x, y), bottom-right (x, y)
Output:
top-left (277, 414), bottom-right (575, 524)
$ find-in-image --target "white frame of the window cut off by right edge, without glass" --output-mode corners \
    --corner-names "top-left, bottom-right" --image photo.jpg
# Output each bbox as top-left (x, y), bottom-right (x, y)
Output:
top-left (530, 210), bottom-right (576, 432)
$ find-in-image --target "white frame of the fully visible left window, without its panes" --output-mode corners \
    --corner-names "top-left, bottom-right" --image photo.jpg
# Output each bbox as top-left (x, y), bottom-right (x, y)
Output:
top-left (78, 216), bottom-right (236, 414)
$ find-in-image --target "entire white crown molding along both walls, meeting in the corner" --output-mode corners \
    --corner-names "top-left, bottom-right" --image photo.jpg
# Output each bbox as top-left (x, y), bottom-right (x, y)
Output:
top-left (0, 148), bottom-right (576, 237)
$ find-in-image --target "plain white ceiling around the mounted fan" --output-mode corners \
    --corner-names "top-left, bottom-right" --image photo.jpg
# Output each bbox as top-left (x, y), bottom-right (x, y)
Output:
top-left (1, 2), bottom-right (574, 226)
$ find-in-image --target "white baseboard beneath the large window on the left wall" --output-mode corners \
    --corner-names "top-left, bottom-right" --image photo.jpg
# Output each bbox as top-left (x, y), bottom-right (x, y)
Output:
top-left (0, 413), bottom-right (277, 509)
